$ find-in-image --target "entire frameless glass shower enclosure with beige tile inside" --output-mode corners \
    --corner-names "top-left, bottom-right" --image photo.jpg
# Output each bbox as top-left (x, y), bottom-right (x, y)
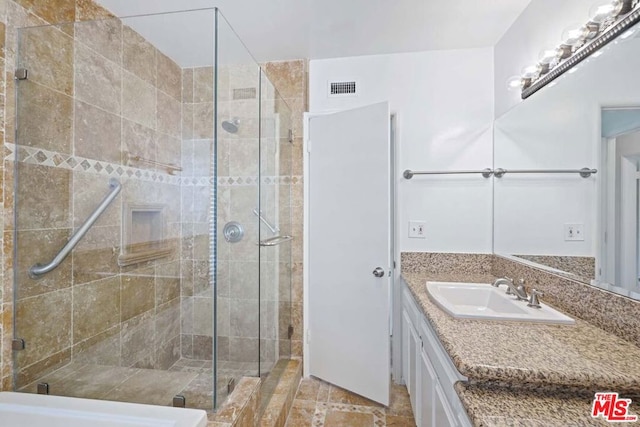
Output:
top-left (6, 9), bottom-right (291, 410)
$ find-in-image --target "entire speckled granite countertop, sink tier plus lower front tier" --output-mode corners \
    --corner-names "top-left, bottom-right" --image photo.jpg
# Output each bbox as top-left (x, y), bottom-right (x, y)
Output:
top-left (402, 273), bottom-right (640, 427)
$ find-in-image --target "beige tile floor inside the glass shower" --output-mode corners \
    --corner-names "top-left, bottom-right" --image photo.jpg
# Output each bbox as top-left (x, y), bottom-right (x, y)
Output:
top-left (20, 359), bottom-right (258, 410)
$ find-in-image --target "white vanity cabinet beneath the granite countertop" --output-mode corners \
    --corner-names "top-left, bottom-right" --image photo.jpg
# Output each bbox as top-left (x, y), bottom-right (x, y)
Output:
top-left (402, 283), bottom-right (471, 427)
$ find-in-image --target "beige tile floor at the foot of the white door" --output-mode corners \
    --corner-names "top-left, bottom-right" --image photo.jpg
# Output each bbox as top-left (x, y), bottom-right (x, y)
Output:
top-left (286, 378), bottom-right (416, 427)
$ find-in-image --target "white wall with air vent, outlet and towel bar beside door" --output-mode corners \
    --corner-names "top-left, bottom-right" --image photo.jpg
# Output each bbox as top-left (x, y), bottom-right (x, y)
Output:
top-left (309, 48), bottom-right (494, 253)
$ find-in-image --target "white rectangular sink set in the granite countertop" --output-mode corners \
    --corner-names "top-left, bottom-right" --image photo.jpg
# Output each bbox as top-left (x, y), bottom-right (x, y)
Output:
top-left (426, 282), bottom-right (575, 325)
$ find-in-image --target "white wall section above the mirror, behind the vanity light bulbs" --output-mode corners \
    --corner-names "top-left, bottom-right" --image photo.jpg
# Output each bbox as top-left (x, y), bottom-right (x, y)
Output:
top-left (495, 0), bottom-right (595, 117)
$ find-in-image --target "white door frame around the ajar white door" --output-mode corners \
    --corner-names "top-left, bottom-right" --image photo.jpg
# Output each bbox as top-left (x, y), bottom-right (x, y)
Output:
top-left (302, 106), bottom-right (402, 382)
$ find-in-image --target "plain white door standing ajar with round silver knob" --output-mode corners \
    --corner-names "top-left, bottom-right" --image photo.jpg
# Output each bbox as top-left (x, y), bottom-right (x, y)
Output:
top-left (305, 102), bottom-right (392, 405)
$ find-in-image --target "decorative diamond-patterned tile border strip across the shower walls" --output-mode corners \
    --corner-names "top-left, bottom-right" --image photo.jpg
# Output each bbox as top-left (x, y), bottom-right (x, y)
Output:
top-left (4, 142), bottom-right (302, 187)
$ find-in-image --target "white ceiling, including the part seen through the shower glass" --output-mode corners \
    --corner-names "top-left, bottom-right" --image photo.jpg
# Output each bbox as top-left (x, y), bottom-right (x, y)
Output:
top-left (97, 0), bottom-right (531, 67)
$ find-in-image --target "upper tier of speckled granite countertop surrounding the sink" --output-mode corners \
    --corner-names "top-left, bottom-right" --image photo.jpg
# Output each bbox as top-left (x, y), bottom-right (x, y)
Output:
top-left (402, 273), bottom-right (640, 393)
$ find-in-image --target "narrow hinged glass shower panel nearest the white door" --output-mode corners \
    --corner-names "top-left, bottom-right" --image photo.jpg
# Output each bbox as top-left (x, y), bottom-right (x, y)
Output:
top-left (260, 71), bottom-right (292, 410)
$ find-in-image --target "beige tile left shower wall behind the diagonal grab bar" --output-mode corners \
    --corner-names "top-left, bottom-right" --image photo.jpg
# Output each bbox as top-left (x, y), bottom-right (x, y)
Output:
top-left (0, 0), bottom-right (182, 389)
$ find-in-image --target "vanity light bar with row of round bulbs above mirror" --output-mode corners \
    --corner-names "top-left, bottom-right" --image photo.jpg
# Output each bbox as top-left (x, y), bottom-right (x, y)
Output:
top-left (507, 0), bottom-right (640, 99)
